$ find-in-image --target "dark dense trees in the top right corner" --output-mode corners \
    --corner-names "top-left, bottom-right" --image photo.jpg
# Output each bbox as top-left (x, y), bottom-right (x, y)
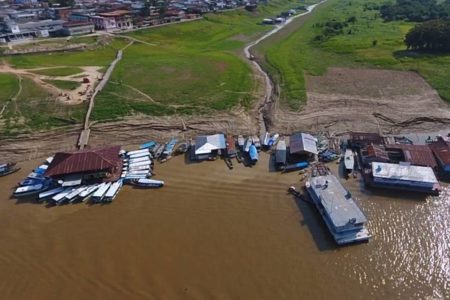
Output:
top-left (380, 0), bottom-right (450, 22)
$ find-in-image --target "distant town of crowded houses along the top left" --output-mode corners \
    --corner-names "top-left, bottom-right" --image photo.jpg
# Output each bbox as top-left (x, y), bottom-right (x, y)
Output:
top-left (0, 0), bottom-right (259, 43)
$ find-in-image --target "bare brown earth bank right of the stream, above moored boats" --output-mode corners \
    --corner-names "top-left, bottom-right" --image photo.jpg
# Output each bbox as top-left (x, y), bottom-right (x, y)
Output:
top-left (273, 68), bottom-right (450, 133)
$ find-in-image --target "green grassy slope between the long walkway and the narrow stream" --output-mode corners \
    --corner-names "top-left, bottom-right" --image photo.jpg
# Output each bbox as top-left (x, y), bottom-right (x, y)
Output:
top-left (93, 0), bottom-right (310, 120)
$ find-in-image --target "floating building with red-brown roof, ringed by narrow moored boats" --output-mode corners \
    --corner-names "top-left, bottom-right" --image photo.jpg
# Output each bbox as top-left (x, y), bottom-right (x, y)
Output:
top-left (44, 146), bottom-right (123, 181)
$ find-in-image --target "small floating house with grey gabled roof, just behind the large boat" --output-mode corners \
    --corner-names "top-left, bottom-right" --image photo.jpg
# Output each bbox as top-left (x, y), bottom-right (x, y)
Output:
top-left (289, 133), bottom-right (318, 163)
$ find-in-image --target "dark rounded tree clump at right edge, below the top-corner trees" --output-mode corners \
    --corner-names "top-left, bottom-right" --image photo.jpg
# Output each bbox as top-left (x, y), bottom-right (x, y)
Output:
top-left (405, 20), bottom-right (450, 51)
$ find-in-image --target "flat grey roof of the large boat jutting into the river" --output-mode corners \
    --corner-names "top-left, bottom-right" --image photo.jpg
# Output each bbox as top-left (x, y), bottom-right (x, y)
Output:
top-left (311, 175), bottom-right (367, 227)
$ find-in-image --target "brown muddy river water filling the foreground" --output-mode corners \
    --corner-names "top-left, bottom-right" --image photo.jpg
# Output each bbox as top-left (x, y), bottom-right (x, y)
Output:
top-left (0, 154), bottom-right (450, 299)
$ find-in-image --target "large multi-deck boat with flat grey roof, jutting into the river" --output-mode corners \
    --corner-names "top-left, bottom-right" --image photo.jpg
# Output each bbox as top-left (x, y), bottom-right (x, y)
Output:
top-left (306, 164), bottom-right (370, 245)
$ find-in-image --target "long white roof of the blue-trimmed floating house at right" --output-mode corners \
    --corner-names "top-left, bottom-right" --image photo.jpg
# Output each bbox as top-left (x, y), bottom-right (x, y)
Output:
top-left (372, 162), bottom-right (438, 183)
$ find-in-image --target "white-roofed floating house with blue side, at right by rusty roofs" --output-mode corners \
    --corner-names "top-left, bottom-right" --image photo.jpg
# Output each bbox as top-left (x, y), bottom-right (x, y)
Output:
top-left (364, 162), bottom-right (441, 194)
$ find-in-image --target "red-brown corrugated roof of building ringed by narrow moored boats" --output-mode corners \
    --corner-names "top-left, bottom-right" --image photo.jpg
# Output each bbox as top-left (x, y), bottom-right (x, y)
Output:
top-left (45, 146), bottom-right (122, 176)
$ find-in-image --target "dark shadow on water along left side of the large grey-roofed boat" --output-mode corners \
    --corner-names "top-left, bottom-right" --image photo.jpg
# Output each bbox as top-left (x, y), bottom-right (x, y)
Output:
top-left (292, 191), bottom-right (337, 251)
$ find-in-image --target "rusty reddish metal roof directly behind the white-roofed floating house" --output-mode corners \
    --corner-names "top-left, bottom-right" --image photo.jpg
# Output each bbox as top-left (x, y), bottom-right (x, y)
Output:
top-left (386, 144), bottom-right (437, 169)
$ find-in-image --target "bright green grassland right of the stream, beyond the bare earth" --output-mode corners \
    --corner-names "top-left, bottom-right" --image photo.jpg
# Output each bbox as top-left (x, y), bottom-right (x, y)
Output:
top-left (265, 0), bottom-right (450, 110)
